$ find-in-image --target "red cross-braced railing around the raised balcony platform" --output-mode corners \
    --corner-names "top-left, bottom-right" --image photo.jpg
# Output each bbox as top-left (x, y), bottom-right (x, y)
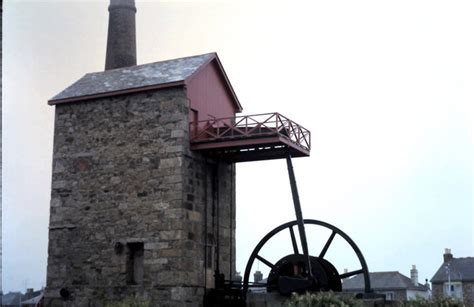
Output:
top-left (189, 113), bottom-right (311, 151)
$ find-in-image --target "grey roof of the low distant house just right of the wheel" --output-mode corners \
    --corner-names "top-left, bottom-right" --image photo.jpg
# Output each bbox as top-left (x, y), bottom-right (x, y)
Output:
top-left (342, 271), bottom-right (428, 291)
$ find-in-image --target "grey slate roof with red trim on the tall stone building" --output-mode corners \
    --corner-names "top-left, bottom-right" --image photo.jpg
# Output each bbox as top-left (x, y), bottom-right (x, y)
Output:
top-left (48, 52), bottom-right (242, 111)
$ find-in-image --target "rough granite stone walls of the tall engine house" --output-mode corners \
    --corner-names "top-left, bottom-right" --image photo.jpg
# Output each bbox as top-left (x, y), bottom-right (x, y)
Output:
top-left (45, 88), bottom-right (235, 306)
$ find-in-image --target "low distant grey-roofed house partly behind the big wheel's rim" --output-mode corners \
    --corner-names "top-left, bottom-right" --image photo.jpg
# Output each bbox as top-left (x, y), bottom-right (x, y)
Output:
top-left (342, 266), bottom-right (431, 301)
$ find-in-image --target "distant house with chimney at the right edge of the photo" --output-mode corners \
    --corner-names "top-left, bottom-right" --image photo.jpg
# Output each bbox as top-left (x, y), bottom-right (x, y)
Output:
top-left (431, 248), bottom-right (474, 306)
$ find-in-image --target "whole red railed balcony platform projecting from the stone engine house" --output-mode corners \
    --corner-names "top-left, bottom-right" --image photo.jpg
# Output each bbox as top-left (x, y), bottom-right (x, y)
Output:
top-left (189, 113), bottom-right (311, 162)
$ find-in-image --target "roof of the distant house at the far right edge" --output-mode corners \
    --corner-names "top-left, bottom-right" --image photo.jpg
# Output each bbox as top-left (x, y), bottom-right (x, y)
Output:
top-left (431, 257), bottom-right (474, 283)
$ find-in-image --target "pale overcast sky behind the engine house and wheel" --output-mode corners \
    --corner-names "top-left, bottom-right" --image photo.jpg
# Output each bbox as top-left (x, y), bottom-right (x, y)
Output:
top-left (2, 0), bottom-right (474, 292)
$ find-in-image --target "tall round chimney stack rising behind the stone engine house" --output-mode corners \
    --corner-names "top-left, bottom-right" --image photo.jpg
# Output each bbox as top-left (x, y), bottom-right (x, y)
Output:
top-left (105, 0), bottom-right (137, 70)
